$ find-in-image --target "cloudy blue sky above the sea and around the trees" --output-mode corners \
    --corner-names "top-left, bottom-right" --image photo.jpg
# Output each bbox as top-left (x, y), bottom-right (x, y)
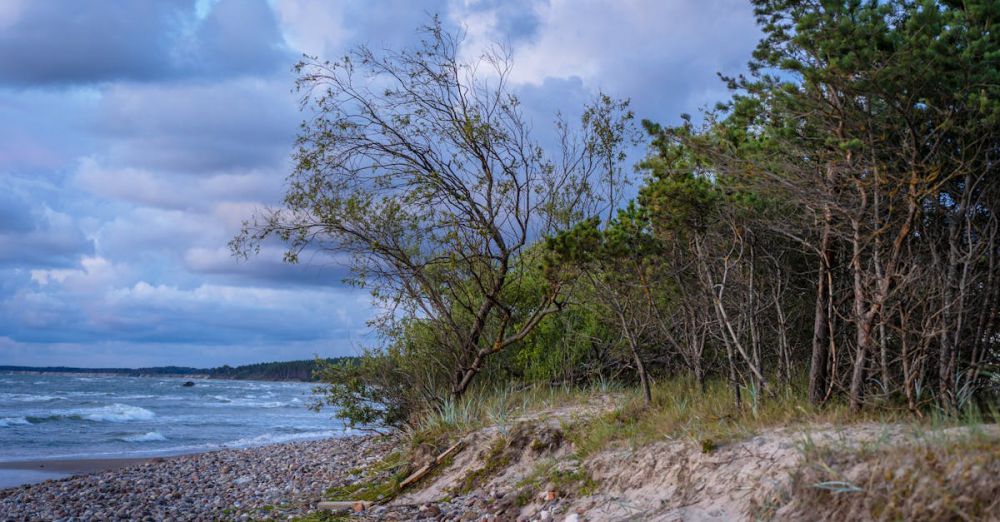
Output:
top-left (0, 0), bottom-right (759, 367)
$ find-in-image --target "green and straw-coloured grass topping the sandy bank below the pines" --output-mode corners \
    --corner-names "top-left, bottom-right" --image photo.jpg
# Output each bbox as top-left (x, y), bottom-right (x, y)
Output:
top-left (306, 372), bottom-right (1000, 522)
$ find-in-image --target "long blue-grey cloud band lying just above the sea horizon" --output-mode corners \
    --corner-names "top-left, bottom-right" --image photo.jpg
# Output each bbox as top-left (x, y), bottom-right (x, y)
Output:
top-left (0, 274), bottom-right (368, 348)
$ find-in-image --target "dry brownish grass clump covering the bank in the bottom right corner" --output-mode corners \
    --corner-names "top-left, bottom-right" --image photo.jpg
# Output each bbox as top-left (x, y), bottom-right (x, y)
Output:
top-left (755, 420), bottom-right (1000, 521)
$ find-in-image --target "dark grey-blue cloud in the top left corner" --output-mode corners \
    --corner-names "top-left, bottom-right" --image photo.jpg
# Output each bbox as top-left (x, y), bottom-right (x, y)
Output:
top-left (0, 0), bottom-right (295, 87)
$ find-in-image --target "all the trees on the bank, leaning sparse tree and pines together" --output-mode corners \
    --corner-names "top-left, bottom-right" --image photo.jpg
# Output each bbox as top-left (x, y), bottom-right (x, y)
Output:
top-left (244, 0), bottom-right (1000, 425)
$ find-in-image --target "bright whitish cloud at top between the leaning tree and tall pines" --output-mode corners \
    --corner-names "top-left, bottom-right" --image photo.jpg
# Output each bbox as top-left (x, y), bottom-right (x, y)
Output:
top-left (449, 0), bottom-right (758, 116)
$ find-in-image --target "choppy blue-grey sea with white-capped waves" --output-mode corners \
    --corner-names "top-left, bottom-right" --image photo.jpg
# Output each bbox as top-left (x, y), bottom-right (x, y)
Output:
top-left (0, 374), bottom-right (347, 462)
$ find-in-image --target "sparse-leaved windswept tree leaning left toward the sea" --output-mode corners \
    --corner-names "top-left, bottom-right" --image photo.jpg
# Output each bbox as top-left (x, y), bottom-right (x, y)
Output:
top-left (231, 19), bottom-right (632, 396)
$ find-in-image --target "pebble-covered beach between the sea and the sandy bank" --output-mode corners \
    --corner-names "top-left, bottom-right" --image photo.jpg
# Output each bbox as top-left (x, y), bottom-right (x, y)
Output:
top-left (0, 436), bottom-right (393, 521)
